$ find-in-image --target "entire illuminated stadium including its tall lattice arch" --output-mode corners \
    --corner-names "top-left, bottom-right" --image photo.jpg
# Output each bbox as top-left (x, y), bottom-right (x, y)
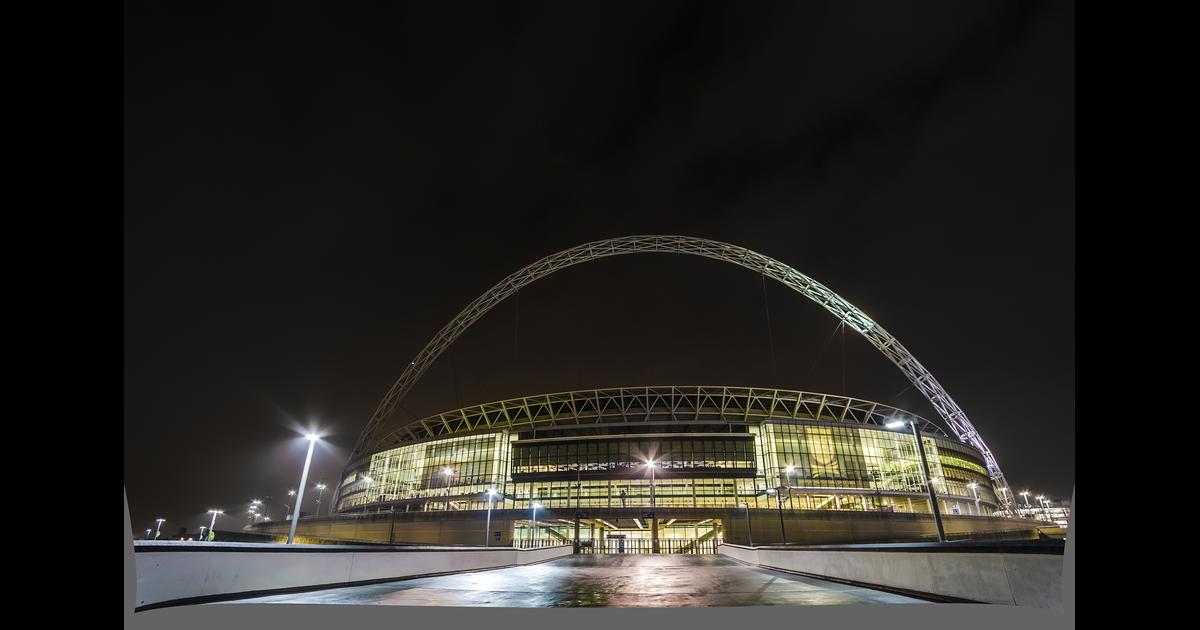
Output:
top-left (251, 236), bottom-right (1037, 553)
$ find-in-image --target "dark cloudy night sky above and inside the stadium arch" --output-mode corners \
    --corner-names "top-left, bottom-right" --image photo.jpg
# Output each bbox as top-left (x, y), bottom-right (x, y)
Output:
top-left (124, 0), bottom-right (1075, 533)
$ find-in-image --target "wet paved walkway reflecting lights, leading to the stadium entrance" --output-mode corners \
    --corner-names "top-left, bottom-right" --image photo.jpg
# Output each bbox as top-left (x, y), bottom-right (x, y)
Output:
top-left (228, 556), bottom-right (922, 608)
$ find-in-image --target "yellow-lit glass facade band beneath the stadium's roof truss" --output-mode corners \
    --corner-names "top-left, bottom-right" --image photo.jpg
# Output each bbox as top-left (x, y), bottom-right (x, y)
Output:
top-left (338, 421), bottom-right (996, 514)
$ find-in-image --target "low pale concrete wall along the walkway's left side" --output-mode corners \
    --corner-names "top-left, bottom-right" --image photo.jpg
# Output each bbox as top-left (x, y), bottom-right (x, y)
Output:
top-left (133, 541), bottom-right (571, 610)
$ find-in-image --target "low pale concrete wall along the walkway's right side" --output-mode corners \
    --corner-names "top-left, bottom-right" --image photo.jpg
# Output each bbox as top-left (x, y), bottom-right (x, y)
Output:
top-left (719, 545), bottom-right (1062, 611)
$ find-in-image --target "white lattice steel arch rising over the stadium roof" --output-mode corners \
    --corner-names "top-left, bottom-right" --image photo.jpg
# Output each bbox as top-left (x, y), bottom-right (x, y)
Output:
top-left (350, 235), bottom-right (1013, 508)
